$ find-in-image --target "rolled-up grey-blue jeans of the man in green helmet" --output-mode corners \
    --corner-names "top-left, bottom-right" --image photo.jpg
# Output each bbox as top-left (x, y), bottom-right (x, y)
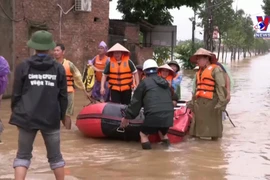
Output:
top-left (13, 128), bottom-right (65, 170)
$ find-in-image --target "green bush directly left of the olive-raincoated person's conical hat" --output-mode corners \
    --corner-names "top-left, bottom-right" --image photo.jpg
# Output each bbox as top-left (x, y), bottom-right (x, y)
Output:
top-left (175, 40), bottom-right (203, 69)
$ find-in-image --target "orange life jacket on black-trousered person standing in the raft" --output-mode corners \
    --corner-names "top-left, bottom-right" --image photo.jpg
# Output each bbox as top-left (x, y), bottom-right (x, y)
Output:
top-left (108, 56), bottom-right (133, 91)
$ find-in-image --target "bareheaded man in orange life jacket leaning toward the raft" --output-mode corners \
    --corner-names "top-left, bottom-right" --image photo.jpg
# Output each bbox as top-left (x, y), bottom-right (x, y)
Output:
top-left (54, 44), bottom-right (90, 129)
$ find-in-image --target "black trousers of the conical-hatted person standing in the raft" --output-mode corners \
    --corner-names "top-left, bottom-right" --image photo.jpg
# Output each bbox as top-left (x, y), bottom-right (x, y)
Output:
top-left (110, 89), bottom-right (132, 105)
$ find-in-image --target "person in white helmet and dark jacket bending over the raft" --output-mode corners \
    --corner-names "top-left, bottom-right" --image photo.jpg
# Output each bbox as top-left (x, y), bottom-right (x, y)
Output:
top-left (121, 59), bottom-right (174, 149)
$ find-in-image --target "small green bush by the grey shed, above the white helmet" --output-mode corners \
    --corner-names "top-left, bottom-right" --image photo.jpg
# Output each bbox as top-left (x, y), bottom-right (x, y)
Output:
top-left (154, 47), bottom-right (171, 66)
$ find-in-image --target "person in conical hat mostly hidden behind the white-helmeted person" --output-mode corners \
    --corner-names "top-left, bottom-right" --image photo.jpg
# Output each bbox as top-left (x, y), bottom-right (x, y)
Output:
top-left (158, 64), bottom-right (179, 106)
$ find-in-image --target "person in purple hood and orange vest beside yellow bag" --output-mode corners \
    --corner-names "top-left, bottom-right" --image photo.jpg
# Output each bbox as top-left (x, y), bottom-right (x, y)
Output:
top-left (88, 41), bottom-right (110, 102)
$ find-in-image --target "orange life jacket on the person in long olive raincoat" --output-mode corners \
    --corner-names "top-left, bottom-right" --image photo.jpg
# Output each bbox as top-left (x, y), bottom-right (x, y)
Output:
top-left (196, 64), bottom-right (217, 99)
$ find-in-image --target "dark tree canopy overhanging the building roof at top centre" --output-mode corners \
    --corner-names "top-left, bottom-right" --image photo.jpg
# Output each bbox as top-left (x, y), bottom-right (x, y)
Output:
top-left (117, 0), bottom-right (204, 25)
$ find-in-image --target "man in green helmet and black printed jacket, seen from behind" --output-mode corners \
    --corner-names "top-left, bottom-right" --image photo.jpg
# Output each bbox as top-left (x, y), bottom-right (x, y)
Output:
top-left (9, 31), bottom-right (67, 180)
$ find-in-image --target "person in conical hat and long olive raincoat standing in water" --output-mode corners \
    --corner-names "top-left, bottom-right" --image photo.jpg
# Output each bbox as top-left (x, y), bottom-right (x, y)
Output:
top-left (187, 48), bottom-right (228, 140)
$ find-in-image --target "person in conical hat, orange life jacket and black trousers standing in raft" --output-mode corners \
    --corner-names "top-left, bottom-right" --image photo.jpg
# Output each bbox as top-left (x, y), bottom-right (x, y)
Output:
top-left (100, 43), bottom-right (139, 104)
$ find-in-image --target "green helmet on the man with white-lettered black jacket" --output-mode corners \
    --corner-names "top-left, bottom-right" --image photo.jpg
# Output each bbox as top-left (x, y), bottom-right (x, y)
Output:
top-left (27, 30), bottom-right (56, 51)
